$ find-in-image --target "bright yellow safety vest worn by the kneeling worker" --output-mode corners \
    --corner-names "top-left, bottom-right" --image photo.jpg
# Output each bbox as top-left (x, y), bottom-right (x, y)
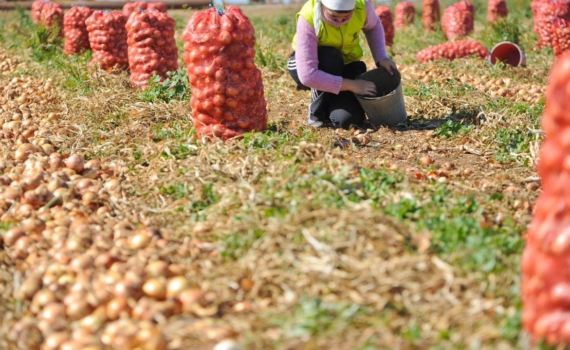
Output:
top-left (292, 0), bottom-right (366, 64)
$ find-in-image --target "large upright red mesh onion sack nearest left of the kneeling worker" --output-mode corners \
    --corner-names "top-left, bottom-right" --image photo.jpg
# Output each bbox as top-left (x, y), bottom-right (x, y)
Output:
top-left (183, 6), bottom-right (267, 140)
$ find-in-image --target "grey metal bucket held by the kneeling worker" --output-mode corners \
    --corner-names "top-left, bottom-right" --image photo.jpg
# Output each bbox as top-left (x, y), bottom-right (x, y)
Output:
top-left (355, 68), bottom-right (407, 127)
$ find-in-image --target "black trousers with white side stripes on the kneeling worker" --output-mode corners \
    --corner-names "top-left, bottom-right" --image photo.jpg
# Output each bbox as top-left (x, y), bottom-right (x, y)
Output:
top-left (287, 46), bottom-right (366, 129)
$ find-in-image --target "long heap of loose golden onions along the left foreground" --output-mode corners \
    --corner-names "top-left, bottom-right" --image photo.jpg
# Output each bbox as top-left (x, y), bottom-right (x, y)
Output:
top-left (0, 73), bottom-right (218, 350)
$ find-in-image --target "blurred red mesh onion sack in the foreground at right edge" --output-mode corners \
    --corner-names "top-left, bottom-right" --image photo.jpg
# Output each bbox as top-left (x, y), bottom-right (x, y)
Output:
top-left (521, 52), bottom-right (570, 345)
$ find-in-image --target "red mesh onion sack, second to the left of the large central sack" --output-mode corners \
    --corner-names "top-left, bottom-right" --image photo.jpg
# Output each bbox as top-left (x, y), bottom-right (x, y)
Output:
top-left (85, 11), bottom-right (129, 70)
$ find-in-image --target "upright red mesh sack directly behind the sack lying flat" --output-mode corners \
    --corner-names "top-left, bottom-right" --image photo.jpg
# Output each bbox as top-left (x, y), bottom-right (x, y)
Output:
top-left (441, 0), bottom-right (475, 40)
